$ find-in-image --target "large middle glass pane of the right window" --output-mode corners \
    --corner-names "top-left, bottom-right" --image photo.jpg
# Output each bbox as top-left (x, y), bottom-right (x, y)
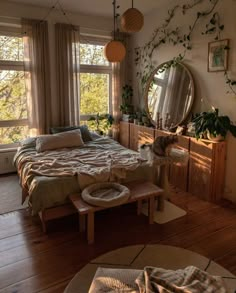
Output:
top-left (80, 73), bottom-right (109, 115)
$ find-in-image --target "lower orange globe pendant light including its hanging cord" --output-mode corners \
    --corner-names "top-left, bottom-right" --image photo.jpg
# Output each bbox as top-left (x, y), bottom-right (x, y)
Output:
top-left (104, 0), bottom-right (126, 62)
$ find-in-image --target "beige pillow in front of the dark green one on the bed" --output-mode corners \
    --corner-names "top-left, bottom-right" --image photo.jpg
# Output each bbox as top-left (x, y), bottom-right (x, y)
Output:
top-left (36, 129), bottom-right (84, 152)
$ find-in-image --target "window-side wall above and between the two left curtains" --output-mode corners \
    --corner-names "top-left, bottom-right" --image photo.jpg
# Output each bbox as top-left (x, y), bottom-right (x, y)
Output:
top-left (0, 0), bottom-right (113, 125)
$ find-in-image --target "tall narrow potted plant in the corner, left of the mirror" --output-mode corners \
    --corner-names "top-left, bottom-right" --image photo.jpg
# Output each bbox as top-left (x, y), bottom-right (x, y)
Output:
top-left (120, 84), bottom-right (133, 122)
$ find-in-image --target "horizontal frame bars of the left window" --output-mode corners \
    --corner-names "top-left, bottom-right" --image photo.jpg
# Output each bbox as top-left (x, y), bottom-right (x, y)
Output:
top-left (0, 26), bottom-right (29, 149)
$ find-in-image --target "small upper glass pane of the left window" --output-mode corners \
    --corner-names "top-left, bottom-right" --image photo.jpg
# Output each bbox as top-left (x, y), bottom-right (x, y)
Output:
top-left (0, 36), bottom-right (23, 61)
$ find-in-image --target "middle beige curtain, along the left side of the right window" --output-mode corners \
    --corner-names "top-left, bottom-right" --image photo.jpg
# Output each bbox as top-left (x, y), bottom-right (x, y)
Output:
top-left (55, 23), bottom-right (80, 126)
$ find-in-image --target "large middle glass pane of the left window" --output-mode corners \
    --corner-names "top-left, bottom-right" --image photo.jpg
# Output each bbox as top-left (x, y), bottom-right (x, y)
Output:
top-left (0, 70), bottom-right (27, 120)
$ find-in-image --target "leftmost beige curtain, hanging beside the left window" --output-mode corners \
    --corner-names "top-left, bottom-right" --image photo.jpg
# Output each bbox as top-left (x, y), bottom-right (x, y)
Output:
top-left (22, 19), bottom-right (51, 135)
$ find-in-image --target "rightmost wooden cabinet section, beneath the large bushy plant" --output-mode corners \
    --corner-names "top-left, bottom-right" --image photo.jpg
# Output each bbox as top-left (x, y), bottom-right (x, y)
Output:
top-left (188, 138), bottom-right (226, 202)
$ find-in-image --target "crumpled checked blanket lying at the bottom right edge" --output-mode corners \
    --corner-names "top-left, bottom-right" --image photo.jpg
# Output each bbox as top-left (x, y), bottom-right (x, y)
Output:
top-left (135, 266), bottom-right (227, 293)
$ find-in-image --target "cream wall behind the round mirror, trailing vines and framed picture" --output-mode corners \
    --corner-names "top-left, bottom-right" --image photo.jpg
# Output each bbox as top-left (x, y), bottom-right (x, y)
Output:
top-left (133, 0), bottom-right (236, 202)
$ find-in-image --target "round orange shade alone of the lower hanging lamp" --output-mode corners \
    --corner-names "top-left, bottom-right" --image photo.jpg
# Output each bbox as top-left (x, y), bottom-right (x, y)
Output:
top-left (104, 40), bottom-right (126, 62)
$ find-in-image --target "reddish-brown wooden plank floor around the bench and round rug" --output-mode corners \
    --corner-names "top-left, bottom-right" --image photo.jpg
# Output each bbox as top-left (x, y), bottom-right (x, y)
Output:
top-left (0, 177), bottom-right (236, 293)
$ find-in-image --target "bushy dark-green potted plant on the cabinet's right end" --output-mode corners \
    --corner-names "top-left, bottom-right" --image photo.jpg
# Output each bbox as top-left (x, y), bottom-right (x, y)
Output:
top-left (193, 109), bottom-right (236, 141)
